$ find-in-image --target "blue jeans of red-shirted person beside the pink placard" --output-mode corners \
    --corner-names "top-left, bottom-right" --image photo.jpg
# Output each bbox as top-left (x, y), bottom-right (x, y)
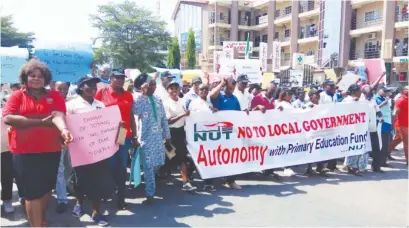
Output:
top-left (110, 138), bottom-right (131, 202)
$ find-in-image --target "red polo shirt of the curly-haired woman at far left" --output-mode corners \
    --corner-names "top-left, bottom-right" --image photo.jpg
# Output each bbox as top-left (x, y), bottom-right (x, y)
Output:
top-left (3, 88), bottom-right (66, 154)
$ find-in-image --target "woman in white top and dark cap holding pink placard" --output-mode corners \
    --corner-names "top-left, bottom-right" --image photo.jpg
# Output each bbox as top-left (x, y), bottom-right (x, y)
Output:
top-left (67, 76), bottom-right (115, 226)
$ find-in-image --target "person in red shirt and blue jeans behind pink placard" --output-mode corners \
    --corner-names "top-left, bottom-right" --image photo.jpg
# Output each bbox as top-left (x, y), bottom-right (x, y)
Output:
top-left (95, 71), bottom-right (137, 210)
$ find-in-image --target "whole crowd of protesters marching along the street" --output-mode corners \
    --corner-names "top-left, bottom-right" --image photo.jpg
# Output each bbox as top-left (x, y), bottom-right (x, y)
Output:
top-left (1, 59), bottom-right (408, 227)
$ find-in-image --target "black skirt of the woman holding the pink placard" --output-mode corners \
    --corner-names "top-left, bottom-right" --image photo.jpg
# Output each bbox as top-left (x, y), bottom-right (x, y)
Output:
top-left (74, 158), bottom-right (115, 200)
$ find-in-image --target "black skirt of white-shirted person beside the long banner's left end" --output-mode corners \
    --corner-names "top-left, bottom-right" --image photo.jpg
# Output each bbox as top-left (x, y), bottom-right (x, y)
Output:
top-left (169, 127), bottom-right (189, 164)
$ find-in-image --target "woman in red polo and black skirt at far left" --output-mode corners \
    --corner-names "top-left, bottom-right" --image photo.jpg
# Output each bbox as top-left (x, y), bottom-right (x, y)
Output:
top-left (3, 60), bottom-right (72, 227)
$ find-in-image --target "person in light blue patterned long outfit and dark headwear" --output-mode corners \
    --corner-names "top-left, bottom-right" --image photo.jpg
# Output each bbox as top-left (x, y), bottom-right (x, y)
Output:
top-left (133, 76), bottom-right (171, 205)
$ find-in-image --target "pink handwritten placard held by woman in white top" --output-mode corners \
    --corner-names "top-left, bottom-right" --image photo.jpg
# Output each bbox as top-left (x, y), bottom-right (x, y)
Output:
top-left (66, 105), bottom-right (121, 167)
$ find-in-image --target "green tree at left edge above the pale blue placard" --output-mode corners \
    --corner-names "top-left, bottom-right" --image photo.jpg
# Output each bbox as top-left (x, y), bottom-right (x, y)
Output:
top-left (0, 15), bottom-right (34, 48)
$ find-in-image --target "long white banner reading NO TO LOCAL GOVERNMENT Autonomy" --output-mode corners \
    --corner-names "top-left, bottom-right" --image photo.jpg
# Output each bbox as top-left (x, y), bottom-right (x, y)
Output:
top-left (185, 102), bottom-right (370, 179)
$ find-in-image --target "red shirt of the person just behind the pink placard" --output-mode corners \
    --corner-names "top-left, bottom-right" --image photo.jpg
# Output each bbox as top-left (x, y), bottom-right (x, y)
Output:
top-left (95, 86), bottom-right (133, 137)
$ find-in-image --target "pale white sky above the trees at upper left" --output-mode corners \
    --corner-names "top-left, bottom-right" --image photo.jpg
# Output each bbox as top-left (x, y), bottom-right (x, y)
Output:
top-left (0, 0), bottom-right (176, 42)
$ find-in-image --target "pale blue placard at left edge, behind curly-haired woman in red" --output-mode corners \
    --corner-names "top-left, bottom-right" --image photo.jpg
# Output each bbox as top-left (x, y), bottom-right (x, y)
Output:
top-left (0, 47), bottom-right (28, 83)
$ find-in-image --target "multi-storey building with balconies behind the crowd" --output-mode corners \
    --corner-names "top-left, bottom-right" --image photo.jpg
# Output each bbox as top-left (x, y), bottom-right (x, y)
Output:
top-left (173, 0), bottom-right (409, 82)
